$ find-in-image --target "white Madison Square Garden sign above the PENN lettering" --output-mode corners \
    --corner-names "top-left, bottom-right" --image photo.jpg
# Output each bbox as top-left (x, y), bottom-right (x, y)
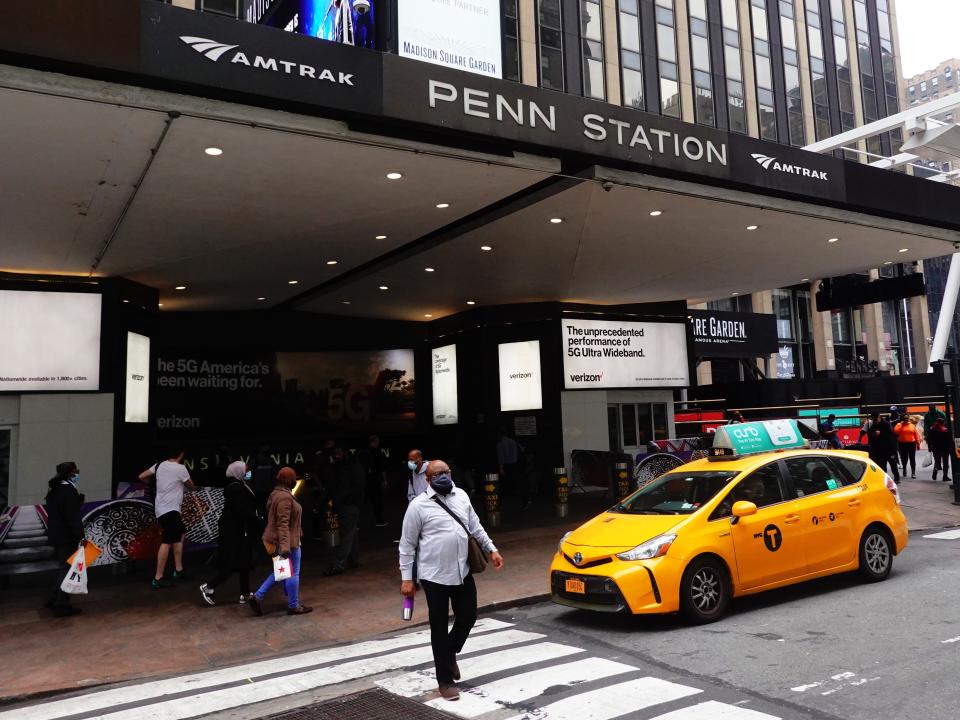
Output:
top-left (397, 0), bottom-right (503, 78)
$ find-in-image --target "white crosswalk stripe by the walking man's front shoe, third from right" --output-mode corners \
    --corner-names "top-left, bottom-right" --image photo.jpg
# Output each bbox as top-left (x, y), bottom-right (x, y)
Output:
top-left (427, 658), bottom-right (636, 718)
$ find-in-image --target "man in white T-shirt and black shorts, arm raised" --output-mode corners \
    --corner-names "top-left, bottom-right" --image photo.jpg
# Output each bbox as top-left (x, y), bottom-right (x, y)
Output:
top-left (140, 450), bottom-right (193, 590)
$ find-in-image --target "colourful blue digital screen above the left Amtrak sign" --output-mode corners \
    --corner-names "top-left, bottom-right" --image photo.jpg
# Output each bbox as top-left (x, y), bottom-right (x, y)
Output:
top-left (261, 0), bottom-right (381, 50)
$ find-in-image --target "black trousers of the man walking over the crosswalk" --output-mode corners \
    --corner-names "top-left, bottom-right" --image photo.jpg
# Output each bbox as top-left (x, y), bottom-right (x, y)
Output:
top-left (420, 575), bottom-right (477, 685)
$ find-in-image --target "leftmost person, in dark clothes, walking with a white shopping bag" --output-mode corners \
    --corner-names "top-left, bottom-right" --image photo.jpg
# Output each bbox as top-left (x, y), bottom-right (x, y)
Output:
top-left (44, 461), bottom-right (87, 617)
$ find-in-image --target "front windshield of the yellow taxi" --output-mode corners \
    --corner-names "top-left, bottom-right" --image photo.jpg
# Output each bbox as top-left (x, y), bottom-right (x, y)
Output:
top-left (609, 471), bottom-right (737, 515)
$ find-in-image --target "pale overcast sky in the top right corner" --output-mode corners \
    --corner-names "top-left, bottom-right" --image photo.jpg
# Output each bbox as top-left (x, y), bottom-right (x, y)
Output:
top-left (897, 0), bottom-right (960, 78)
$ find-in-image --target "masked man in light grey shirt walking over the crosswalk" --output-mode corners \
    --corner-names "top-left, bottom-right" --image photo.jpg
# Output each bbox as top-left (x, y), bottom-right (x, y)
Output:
top-left (400, 460), bottom-right (503, 700)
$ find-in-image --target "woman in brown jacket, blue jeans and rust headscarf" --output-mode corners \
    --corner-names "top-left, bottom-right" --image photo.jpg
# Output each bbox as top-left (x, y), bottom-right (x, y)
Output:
top-left (247, 467), bottom-right (313, 615)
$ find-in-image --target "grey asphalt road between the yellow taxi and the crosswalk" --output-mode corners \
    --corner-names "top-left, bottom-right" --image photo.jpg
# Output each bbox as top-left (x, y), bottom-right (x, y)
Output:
top-left (511, 535), bottom-right (960, 720)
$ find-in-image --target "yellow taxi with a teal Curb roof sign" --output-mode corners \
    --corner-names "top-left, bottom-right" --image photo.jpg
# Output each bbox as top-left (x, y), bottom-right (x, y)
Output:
top-left (550, 420), bottom-right (907, 623)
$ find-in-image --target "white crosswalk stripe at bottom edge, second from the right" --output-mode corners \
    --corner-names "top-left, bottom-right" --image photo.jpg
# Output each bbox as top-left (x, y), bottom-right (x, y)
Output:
top-left (502, 677), bottom-right (703, 720)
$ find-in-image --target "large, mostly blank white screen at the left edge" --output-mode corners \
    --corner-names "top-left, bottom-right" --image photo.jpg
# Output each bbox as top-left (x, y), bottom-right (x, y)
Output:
top-left (0, 290), bottom-right (101, 392)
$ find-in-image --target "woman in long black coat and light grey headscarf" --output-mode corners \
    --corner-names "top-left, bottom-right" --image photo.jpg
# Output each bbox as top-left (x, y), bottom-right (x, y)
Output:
top-left (200, 460), bottom-right (263, 605)
